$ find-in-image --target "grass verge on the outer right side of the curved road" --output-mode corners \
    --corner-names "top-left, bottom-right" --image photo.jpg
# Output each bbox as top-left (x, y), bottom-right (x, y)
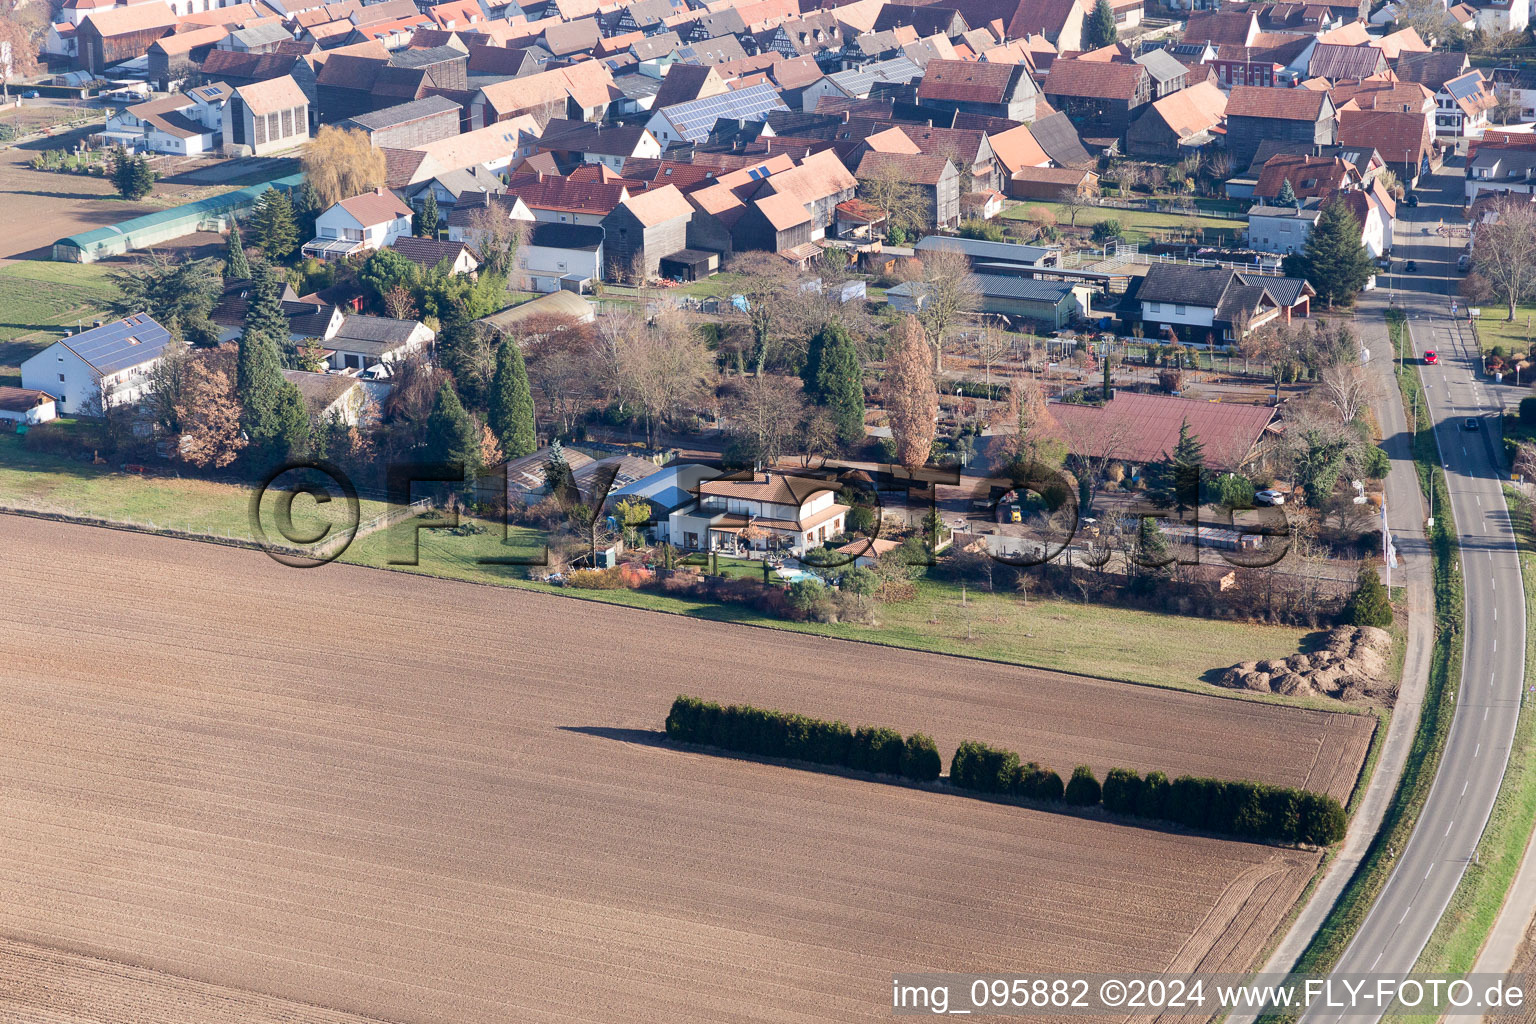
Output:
top-left (1402, 485), bottom-right (1536, 994)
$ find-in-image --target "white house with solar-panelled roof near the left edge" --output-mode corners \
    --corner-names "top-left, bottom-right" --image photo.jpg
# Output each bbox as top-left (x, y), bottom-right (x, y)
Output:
top-left (22, 313), bottom-right (170, 416)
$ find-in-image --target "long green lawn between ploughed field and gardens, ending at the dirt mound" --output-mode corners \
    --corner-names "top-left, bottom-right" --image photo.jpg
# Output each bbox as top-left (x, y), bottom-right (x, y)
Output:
top-left (341, 515), bottom-right (1339, 709)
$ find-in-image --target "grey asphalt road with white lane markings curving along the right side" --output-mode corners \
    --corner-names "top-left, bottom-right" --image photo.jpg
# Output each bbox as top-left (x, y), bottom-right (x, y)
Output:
top-left (1309, 161), bottom-right (1525, 1024)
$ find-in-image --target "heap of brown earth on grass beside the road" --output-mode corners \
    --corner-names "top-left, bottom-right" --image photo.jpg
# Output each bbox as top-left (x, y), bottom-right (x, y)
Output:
top-left (1217, 626), bottom-right (1398, 705)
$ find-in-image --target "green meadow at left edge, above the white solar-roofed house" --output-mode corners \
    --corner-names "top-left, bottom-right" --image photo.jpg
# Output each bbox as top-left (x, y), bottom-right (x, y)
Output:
top-left (0, 261), bottom-right (117, 385)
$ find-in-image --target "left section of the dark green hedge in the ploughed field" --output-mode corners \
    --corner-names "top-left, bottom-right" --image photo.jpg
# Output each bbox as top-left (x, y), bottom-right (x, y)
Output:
top-left (667, 697), bottom-right (943, 781)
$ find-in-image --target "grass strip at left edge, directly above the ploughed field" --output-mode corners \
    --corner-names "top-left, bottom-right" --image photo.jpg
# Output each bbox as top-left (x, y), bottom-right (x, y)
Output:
top-left (0, 432), bottom-right (384, 542)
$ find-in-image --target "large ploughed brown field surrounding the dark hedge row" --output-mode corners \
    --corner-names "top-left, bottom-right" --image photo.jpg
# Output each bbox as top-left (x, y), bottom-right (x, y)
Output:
top-left (0, 517), bottom-right (1369, 1024)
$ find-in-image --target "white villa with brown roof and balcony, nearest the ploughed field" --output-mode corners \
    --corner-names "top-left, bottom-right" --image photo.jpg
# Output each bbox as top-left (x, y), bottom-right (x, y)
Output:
top-left (667, 473), bottom-right (848, 554)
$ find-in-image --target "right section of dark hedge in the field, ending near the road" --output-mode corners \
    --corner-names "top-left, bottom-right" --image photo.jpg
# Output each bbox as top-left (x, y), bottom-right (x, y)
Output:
top-left (949, 740), bottom-right (1347, 846)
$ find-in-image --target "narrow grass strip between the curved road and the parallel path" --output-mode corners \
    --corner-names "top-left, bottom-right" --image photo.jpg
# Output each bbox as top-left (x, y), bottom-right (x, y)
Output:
top-left (1264, 307), bottom-right (1465, 1021)
